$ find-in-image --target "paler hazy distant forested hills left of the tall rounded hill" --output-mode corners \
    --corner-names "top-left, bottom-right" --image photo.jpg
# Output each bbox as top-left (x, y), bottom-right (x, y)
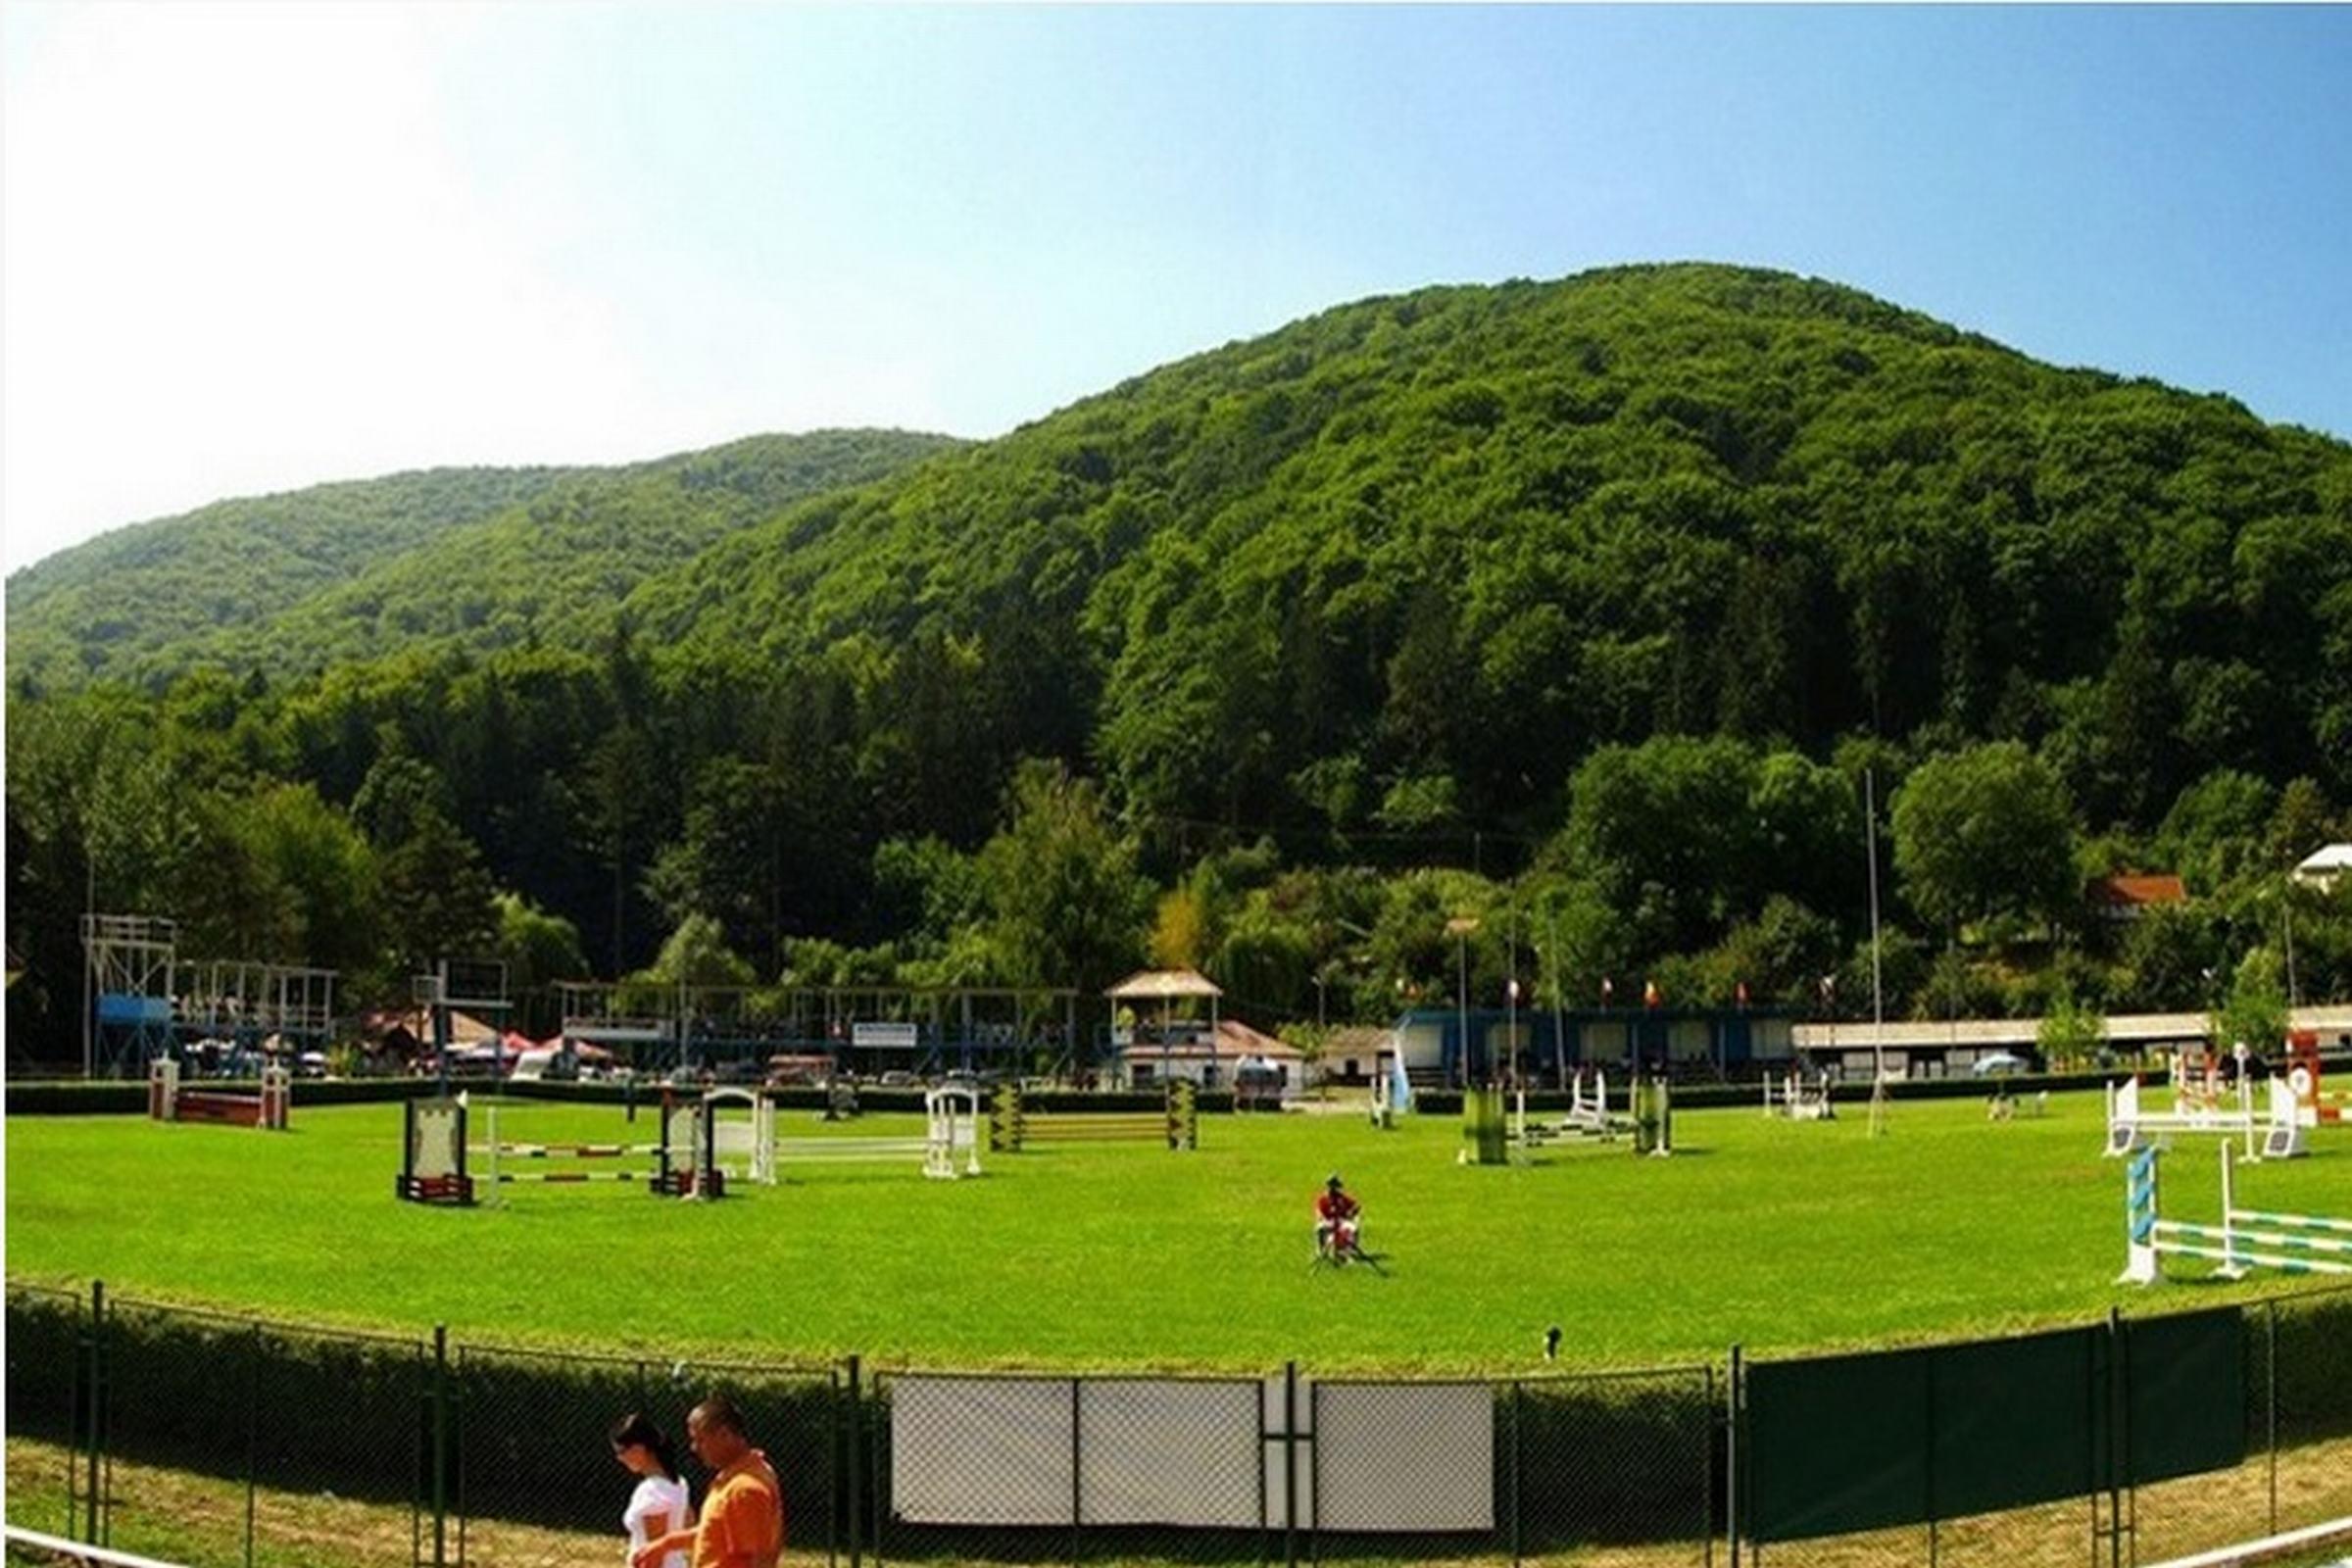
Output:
top-left (7, 430), bottom-right (953, 686)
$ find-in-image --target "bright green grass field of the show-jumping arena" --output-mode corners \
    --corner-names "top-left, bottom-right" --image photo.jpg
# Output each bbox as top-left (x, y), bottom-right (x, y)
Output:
top-left (7, 1096), bottom-right (2352, 1371)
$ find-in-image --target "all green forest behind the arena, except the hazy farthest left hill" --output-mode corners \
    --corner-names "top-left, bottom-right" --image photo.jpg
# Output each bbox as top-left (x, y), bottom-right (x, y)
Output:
top-left (7, 266), bottom-right (2352, 1067)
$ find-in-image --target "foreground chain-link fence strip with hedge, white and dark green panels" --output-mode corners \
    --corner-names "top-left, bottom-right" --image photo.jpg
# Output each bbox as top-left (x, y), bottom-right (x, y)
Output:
top-left (5, 1284), bottom-right (2352, 1568)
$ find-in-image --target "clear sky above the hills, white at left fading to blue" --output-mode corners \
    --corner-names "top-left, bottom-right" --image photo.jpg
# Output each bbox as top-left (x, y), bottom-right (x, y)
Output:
top-left (0, 5), bottom-right (2352, 566)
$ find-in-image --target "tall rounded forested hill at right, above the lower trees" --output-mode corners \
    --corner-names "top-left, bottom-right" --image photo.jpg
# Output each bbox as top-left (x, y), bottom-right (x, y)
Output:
top-left (633, 266), bottom-right (2352, 832)
